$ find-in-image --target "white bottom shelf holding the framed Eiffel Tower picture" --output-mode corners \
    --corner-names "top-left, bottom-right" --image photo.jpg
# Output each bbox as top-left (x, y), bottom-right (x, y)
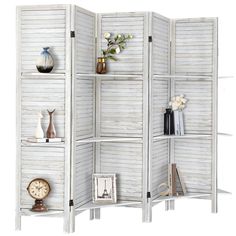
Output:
top-left (76, 201), bottom-right (141, 211)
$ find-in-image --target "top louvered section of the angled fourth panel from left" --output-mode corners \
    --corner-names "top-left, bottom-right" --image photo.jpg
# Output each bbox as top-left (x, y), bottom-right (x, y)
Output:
top-left (152, 14), bottom-right (170, 74)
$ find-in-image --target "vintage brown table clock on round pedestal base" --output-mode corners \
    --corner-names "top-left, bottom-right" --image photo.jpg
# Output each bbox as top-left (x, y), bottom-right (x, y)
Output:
top-left (27, 178), bottom-right (51, 212)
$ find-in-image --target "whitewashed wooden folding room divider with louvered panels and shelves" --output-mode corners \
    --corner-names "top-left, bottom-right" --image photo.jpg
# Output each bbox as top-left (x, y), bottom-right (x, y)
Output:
top-left (16, 5), bottom-right (218, 232)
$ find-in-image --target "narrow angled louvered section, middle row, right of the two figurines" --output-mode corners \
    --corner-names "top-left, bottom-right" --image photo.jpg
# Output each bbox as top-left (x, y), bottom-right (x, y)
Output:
top-left (75, 77), bottom-right (95, 139)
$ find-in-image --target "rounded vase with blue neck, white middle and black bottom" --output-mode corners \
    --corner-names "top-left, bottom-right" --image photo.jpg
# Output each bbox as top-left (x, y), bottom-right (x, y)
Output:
top-left (36, 47), bottom-right (54, 73)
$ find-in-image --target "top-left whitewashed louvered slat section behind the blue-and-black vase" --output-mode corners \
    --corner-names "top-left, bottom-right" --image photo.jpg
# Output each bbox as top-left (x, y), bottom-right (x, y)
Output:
top-left (20, 9), bottom-right (66, 73)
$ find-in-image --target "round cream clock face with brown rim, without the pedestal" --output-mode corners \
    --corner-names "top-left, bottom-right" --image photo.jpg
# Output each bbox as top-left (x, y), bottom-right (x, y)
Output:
top-left (27, 179), bottom-right (50, 200)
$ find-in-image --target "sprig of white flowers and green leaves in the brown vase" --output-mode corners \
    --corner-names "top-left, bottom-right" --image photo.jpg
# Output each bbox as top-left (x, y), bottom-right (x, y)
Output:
top-left (102, 32), bottom-right (133, 61)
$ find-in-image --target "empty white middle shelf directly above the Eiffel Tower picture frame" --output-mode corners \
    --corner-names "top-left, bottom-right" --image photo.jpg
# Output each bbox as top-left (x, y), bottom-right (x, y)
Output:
top-left (76, 137), bottom-right (142, 143)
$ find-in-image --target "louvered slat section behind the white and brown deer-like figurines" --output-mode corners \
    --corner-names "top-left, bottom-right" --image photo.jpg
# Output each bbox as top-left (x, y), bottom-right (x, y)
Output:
top-left (21, 77), bottom-right (65, 138)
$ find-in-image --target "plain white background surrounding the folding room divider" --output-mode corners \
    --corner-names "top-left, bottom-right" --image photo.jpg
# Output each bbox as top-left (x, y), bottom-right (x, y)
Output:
top-left (0, 0), bottom-right (236, 236)
